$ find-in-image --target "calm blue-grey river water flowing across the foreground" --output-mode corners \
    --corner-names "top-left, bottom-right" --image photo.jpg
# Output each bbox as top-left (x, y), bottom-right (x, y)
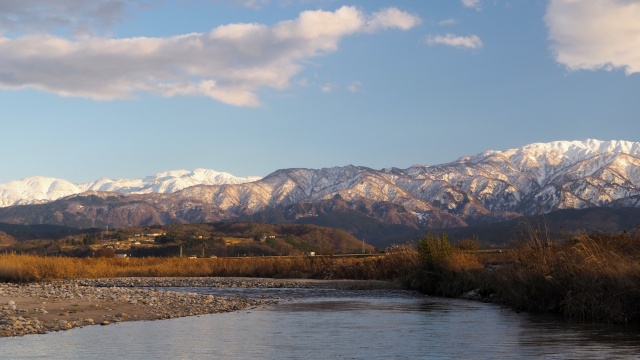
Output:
top-left (0, 288), bottom-right (640, 360)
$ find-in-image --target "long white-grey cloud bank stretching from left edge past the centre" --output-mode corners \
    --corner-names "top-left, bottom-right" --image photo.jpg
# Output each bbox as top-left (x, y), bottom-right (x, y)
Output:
top-left (0, 6), bottom-right (420, 106)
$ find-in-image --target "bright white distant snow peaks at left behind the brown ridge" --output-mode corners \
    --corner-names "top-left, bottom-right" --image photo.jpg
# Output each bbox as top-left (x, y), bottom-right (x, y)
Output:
top-left (0, 169), bottom-right (260, 207)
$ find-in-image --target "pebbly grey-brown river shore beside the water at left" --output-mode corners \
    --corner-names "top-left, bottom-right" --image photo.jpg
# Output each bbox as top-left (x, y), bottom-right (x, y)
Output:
top-left (0, 278), bottom-right (396, 337)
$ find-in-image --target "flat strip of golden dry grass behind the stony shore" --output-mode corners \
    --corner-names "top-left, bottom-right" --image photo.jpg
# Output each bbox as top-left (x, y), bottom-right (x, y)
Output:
top-left (0, 251), bottom-right (415, 282)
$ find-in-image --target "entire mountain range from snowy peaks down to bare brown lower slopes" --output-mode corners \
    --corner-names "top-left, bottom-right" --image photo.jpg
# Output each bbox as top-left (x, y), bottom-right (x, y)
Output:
top-left (0, 139), bottom-right (640, 246)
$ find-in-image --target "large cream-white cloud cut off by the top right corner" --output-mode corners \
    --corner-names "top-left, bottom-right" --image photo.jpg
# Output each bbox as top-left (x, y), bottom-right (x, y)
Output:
top-left (545, 0), bottom-right (640, 74)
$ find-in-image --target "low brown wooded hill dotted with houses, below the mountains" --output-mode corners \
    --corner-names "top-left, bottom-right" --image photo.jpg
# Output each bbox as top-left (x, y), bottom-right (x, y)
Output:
top-left (2, 222), bottom-right (375, 257)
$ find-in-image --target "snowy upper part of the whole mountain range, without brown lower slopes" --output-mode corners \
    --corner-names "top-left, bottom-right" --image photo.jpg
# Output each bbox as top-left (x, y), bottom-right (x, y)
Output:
top-left (0, 139), bottom-right (640, 222)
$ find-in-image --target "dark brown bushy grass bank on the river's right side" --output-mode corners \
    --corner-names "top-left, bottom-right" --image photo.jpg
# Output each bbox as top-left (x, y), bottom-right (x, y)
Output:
top-left (408, 232), bottom-right (640, 323)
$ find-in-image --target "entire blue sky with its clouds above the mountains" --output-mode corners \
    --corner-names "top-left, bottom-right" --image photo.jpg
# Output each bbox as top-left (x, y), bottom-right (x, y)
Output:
top-left (0, 0), bottom-right (640, 183)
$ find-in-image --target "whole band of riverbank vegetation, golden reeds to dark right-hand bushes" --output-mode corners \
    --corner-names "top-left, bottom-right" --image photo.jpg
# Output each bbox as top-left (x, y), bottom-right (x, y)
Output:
top-left (0, 227), bottom-right (640, 323)
